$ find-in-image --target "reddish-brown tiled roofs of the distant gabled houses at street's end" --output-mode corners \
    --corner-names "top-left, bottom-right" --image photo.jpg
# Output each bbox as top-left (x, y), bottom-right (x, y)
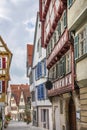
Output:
top-left (10, 84), bottom-right (31, 106)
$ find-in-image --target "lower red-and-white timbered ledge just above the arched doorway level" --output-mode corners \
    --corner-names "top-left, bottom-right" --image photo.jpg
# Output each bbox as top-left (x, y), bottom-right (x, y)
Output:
top-left (48, 73), bottom-right (73, 97)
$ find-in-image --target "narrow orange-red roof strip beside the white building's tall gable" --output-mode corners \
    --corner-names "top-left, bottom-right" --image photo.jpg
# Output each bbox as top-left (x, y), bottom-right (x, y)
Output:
top-left (27, 44), bottom-right (33, 66)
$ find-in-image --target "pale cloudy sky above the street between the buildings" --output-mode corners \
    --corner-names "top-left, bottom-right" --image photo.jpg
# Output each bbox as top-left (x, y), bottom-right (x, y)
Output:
top-left (0, 0), bottom-right (39, 84)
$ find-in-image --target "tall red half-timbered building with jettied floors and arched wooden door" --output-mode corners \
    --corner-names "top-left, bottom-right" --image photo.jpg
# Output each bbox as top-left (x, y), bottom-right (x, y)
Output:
top-left (39, 0), bottom-right (80, 130)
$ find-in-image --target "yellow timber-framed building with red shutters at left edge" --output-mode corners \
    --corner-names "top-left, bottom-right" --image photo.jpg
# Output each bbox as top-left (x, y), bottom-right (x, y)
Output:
top-left (0, 36), bottom-right (12, 128)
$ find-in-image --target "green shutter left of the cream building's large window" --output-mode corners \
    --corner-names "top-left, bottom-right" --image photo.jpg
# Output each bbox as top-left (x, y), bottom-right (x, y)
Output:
top-left (74, 35), bottom-right (79, 59)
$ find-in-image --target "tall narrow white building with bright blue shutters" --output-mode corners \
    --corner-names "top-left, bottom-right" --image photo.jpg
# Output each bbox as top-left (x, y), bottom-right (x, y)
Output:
top-left (27, 12), bottom-right (52, 130)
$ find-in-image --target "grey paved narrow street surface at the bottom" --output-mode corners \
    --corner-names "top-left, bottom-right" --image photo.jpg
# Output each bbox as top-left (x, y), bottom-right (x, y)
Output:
top-left (4, 121), bottom-right (44, 130)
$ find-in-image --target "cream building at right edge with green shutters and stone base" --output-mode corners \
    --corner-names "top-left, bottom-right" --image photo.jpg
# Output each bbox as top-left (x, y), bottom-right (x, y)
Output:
top-left (67, 0), bottom-right (87, 130)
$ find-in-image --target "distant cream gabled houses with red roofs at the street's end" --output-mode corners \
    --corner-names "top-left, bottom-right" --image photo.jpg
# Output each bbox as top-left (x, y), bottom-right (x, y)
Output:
top-left (10, 84), bottom-right (31, 121)
